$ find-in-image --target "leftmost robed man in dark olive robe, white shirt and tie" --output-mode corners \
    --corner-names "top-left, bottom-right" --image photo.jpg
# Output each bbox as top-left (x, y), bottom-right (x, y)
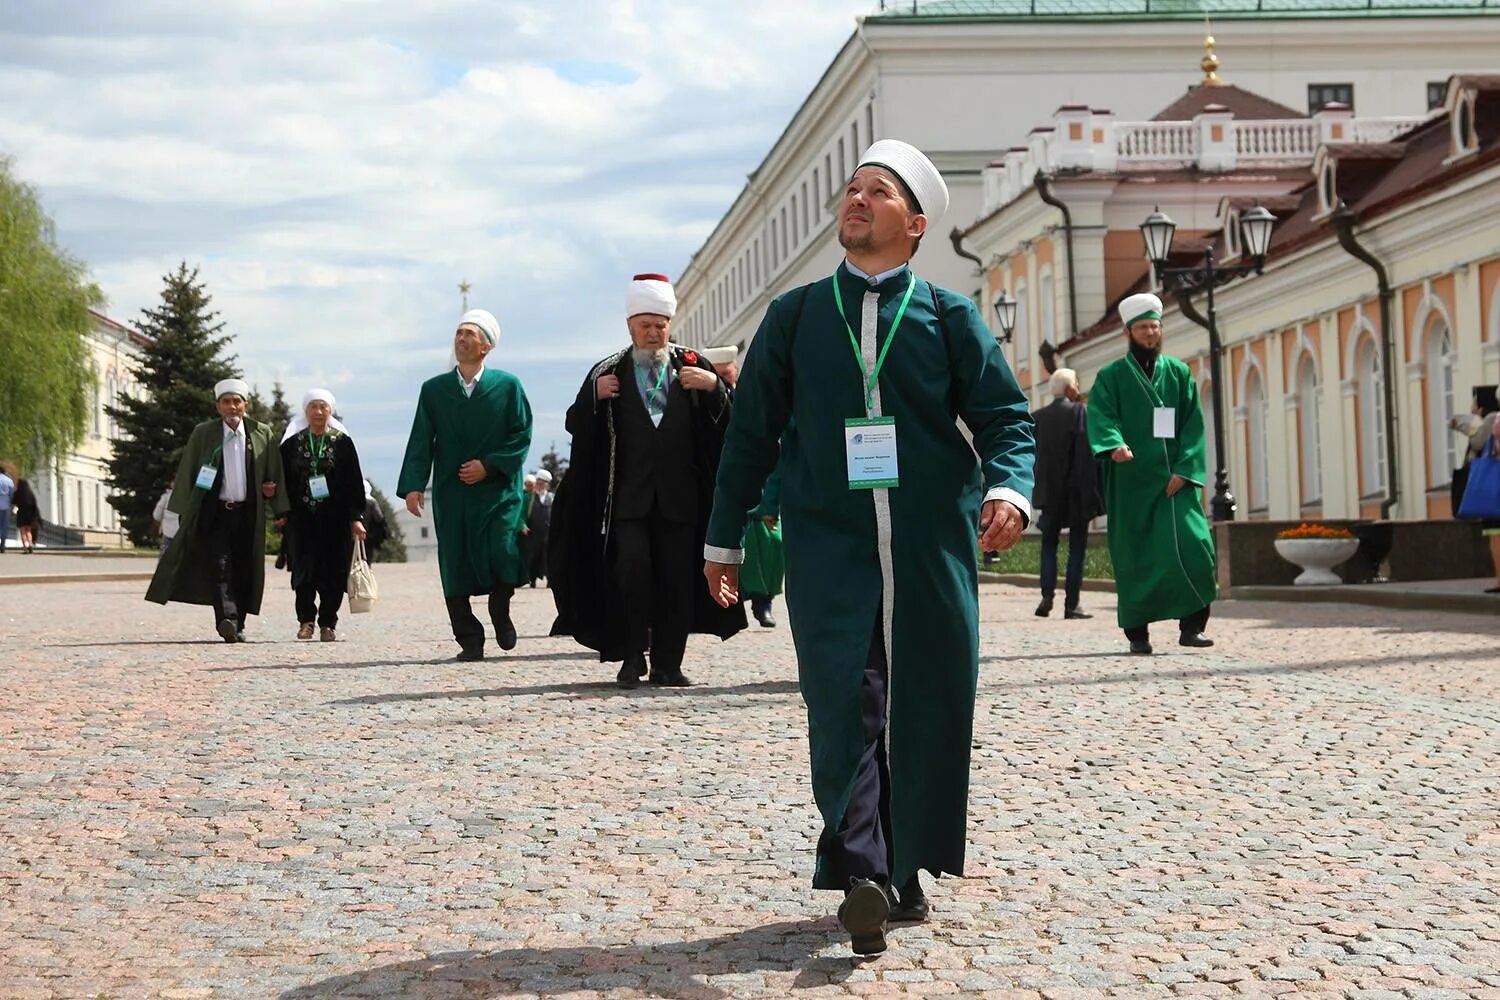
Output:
top-left (146, 378), bottom-right (291, 642)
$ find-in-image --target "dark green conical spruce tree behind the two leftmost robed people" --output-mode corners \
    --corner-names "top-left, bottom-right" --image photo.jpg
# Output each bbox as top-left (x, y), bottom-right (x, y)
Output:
top-left (110, 261), bottom-right (236, 546)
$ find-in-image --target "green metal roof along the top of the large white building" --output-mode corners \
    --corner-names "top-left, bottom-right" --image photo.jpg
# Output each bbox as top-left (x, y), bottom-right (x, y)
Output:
top-left (867, 0), bottom-right (1500, 24)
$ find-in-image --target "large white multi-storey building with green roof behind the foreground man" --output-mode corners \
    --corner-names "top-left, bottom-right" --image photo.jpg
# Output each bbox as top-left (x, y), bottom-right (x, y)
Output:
top-left (674, 0), bottom-right (1500, 358)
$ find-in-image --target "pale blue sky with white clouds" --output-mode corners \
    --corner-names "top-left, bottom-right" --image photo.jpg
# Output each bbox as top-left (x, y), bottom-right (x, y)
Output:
top-left (0, 0), bottom-right (875, 492)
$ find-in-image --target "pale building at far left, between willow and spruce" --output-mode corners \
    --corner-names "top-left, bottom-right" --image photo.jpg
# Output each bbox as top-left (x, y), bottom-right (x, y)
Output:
top-left (21, 312), bottom-right (146, 546)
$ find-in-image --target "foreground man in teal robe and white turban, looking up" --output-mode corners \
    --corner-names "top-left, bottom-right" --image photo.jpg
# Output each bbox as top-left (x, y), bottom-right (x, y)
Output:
top-left (704, 139), bottom-right (1034, 954)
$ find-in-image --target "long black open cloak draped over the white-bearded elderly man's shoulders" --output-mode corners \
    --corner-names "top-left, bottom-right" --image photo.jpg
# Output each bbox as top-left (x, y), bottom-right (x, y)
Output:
top-left (548, 346), bottom-right (746, 661)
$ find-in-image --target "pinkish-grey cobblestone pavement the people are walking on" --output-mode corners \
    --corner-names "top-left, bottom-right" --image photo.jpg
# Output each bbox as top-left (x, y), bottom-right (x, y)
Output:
top-left (0, 565), bottom-right (1500, 1000)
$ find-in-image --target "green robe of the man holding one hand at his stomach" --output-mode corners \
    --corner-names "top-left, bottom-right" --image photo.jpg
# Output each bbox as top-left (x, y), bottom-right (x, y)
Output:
top-left (396, 369), bottom-right (531, 597)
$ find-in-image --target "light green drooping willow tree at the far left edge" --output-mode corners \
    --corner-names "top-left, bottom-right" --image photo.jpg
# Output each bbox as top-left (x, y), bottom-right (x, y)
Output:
top-left (0, 156), bottom-right (104, 478)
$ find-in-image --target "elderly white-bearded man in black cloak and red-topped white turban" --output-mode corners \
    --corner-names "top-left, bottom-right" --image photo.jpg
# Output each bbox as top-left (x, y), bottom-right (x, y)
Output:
top-left (548, 274), bottom-right (746, 688)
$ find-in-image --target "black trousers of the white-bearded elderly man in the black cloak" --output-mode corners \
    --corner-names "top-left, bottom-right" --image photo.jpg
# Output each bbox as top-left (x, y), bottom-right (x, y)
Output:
top-left (611, 507), bottom-right (704, 675)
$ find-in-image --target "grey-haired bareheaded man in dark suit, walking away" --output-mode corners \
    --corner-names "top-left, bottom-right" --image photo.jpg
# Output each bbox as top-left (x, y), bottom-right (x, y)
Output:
top-left (1032, 367), bottom-right (1100, 618)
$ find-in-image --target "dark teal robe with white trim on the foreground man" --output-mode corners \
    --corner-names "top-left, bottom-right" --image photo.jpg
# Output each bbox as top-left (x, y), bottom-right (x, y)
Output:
top-left (707, 267), bottom-right (1034, 889)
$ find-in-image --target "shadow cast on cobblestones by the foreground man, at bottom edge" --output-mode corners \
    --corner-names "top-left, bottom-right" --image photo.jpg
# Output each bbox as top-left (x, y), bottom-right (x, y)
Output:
top-left (281, 918), bottom-right (858, 1000)
